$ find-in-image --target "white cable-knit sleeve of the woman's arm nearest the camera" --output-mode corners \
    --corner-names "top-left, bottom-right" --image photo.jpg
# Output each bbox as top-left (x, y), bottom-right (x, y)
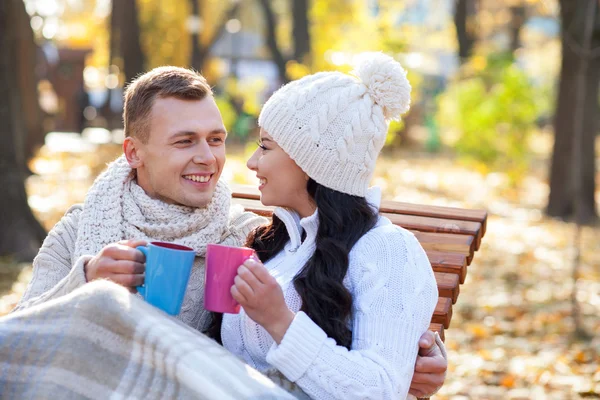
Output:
top-left (267, 226), bottom-right (438, 399)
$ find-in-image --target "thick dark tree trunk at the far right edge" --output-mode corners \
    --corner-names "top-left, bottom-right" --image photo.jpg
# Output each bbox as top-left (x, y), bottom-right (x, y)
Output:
top-left (546, 0), bottom-right (600, 223)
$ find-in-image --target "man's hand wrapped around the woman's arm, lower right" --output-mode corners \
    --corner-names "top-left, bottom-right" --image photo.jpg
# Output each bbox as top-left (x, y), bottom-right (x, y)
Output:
top-left (409, 331), bottom-right (448, 397)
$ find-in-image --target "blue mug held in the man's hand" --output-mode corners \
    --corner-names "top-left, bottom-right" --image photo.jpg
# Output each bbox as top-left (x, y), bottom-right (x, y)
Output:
top-left (137, 242), bottom-right (196, 315)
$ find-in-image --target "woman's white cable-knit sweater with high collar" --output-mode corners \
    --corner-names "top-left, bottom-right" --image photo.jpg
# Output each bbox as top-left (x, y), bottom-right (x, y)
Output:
top-left (221, 189), bottom-right (438, 400)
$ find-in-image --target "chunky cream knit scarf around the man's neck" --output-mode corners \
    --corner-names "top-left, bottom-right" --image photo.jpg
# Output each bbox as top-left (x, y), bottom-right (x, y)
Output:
top-left (74, 156), bottom-right (239, 259)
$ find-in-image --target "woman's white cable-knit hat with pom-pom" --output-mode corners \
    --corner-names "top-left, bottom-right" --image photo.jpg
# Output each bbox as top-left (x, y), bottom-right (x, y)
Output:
top-left (258, 53), bottom-right (411, 197)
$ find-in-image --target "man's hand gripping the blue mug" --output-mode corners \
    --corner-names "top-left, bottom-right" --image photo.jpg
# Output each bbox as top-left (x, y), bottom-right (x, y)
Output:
top-left (84, 240), bottom-right (146, 293)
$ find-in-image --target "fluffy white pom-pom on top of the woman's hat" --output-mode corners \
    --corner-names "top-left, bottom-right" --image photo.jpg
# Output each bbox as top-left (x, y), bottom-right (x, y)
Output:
top-left (352, 52), bottom-right (411, 120)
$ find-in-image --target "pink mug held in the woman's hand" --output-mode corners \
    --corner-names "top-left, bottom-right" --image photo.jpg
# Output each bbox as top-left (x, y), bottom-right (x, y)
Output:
top-left (204, 244), bottom-right (256, 314)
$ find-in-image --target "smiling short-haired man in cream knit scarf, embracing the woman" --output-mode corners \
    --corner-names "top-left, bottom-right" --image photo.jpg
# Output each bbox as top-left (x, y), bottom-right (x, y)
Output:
top-left (15, 67), bottom-right (446, 395)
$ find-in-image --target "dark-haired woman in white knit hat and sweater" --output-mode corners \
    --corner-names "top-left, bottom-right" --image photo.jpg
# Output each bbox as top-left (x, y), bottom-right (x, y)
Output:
top-left (210, 53), bottom-right (438, 399)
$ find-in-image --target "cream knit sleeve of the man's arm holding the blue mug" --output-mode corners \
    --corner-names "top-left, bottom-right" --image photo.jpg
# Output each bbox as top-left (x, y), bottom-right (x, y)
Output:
top-left (13, 206), bottom-right (92, 312)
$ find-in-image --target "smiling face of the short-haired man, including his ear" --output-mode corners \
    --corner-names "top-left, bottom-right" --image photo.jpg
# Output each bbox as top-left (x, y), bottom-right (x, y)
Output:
top-left (124, 96), bottom-right (227, 207)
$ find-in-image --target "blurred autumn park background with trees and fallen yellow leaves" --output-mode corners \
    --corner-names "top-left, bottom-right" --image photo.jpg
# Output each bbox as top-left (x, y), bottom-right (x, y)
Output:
top-left (0, 0), bottom-right (600, 399)
